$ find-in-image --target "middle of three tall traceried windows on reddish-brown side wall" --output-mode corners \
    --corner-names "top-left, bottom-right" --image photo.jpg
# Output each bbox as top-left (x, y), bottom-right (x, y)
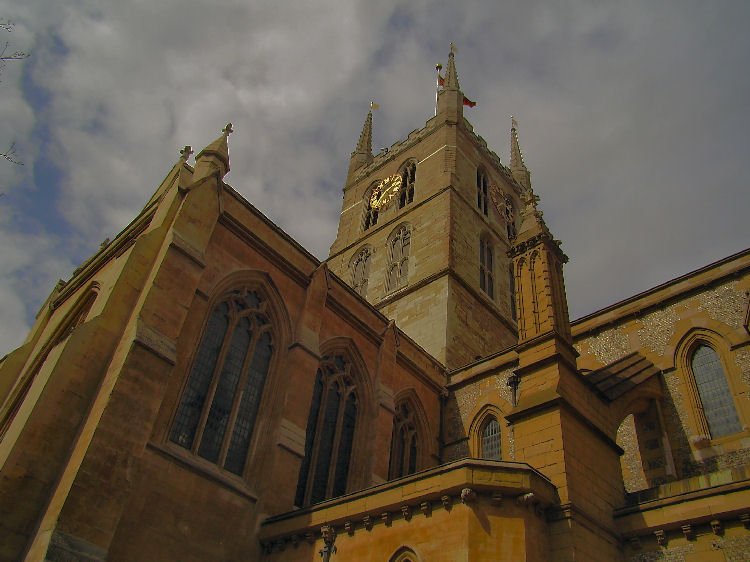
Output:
top-left (294, 354), bottom-right (359, 506)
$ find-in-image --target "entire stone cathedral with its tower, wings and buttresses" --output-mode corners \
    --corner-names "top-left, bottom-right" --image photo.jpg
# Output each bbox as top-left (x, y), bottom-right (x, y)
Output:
top-left (0, 53), bottom-right (750, 562)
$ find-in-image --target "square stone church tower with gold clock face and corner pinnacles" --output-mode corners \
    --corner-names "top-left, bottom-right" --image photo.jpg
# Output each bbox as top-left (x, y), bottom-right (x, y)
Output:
top-left (327, 50), bottom-right (530, 368)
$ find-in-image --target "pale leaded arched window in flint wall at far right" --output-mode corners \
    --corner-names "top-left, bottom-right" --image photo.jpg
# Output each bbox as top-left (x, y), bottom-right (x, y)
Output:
top-left (690, 345), bottom-right (742, 439)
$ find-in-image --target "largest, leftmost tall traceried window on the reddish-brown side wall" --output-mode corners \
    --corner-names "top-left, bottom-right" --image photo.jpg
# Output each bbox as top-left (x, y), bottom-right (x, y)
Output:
top-left (169, 288), bottom-right (274, 475)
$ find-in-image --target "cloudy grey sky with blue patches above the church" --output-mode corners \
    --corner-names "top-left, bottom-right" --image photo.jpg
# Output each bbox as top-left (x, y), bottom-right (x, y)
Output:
top-left (0, 0), bottom-right (750, 355)
